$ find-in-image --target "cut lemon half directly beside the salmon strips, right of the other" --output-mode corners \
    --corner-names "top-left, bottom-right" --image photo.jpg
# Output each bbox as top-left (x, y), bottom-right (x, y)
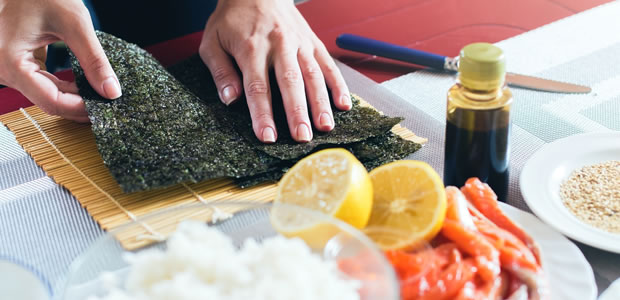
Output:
top-left (366, 160), bottom-right (446, 250)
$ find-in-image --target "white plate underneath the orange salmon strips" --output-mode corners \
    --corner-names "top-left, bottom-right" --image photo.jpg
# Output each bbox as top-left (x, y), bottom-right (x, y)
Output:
top-left (500, 203), bottom-right (597, 300)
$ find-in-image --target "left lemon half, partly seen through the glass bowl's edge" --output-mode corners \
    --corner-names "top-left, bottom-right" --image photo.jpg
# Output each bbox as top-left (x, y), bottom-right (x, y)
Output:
top-left (271, 148), bottom-right (373, 247)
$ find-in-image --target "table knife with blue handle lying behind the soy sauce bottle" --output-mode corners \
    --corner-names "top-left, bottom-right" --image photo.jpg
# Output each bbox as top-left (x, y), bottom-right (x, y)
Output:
top-left (336, 33), bottom-right (592, 93)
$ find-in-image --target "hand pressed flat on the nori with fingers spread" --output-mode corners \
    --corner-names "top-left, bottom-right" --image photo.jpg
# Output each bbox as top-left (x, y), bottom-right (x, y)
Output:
top-left (200, 0), bottom-right (352, 143)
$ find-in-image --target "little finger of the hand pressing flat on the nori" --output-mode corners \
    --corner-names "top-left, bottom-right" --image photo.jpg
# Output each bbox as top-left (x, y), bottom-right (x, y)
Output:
top-left (315, 44), bottom-right (353, 110)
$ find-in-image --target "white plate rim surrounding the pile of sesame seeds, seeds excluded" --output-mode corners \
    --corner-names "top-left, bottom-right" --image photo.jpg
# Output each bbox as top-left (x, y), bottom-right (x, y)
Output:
top-left (519, 132), bottom-right (620, 253)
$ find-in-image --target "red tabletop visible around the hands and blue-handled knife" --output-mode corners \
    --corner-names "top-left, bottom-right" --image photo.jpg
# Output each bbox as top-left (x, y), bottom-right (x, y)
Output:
top-left (0, 0), bottom-right (618, 298)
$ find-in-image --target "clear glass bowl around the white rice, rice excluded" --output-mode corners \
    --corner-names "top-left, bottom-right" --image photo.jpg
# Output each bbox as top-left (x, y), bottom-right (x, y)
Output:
top-left (56, 202), bottom-right (399, 300)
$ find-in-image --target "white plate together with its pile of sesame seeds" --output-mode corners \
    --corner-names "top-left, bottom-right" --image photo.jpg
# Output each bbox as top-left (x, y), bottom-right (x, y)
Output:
top-left (519, 131), bottom-right (620, 253)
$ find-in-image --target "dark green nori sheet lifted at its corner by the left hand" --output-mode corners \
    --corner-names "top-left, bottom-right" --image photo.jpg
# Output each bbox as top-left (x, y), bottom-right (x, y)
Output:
top-left (72, 32), bottom-right (279, 192)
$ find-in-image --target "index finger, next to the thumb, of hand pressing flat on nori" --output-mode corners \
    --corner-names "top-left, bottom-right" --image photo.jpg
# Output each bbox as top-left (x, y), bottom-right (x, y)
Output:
top-left (239, 48), bottom-right (278, 143)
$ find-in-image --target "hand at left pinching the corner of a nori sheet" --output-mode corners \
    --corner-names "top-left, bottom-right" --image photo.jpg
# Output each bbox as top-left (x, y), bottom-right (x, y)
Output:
top-left (0, 0), bottom-right (121, 122)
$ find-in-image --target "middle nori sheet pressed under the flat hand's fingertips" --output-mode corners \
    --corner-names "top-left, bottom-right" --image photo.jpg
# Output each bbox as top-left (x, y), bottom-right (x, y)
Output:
top-left (169, 55), bottom-right (402, 160)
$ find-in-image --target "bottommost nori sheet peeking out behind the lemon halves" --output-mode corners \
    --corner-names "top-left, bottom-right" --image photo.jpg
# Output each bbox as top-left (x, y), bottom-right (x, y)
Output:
top-left (235, 132), bottom-right (422, 188)
